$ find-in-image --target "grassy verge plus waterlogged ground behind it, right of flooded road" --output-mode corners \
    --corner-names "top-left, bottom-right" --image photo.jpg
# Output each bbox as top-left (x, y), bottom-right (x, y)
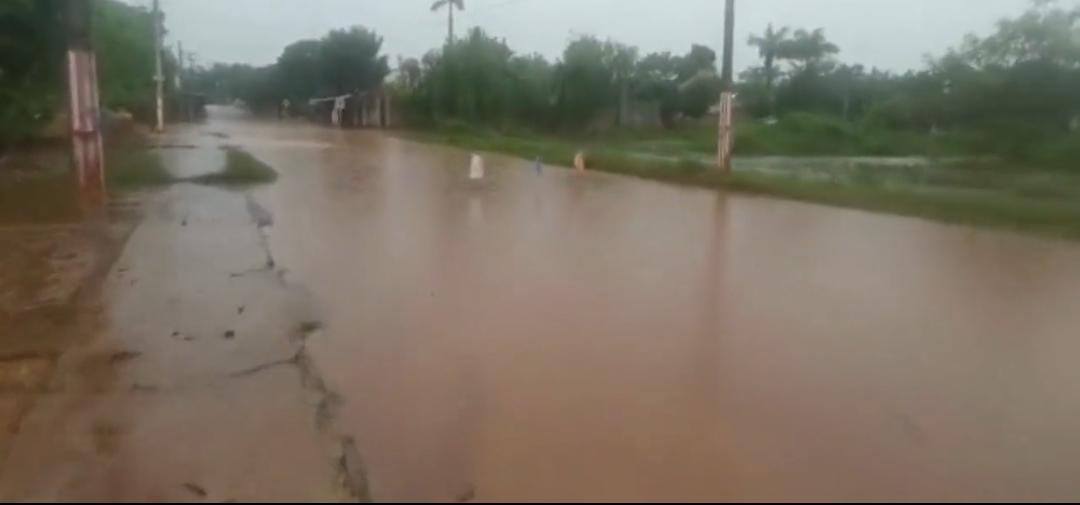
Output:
top-left (404, 125), bottom-right (1080, 238)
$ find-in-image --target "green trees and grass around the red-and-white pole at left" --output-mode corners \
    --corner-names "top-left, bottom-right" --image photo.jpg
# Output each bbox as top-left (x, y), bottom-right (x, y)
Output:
top-left (0, 0), bottom-right (278, 190)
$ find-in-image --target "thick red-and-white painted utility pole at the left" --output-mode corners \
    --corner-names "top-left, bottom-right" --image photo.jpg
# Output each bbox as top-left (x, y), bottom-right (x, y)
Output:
top-left (65, 0), bottom-right (105, 203)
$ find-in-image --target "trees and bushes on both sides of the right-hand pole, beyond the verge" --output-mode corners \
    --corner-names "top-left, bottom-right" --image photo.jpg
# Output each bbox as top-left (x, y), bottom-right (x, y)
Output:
top-left (392, 0), bottom-right (1080, 169)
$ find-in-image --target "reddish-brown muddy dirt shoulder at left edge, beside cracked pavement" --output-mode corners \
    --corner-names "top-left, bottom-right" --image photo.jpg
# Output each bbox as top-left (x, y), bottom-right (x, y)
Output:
top-left (0, 193), bottom-right (137, 461)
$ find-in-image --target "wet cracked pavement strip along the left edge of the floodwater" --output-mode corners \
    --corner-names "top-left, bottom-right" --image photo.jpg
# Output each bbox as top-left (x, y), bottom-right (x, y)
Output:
top-left (0, 181), bottom-right (364, 501)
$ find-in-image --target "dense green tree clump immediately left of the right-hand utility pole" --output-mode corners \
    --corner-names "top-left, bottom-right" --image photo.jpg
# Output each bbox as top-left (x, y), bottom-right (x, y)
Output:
top-left (394, 28), bottom-right (720, 128)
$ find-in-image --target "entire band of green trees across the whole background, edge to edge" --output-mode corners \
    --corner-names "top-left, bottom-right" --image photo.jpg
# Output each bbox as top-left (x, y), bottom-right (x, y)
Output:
top-left (0, 0), bottom-right (1080, 164)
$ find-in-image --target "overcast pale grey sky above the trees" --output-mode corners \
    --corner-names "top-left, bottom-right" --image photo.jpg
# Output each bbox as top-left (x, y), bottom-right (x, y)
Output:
top-left (125, 0), bottom-right (1045, 70)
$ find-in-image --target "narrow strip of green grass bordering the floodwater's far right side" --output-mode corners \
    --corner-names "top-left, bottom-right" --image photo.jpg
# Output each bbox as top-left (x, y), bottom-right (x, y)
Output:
top-left (407, 129), bottom-right (1080, 238)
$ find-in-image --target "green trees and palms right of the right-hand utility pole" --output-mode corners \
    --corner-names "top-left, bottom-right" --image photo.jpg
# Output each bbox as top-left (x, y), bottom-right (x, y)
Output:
top-left (739, 0), bottom-right (1080, 159)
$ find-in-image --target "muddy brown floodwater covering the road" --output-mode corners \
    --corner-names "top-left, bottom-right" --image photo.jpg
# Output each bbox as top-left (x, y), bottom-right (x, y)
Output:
top-left (214, 110), bottom-right (1080, 501)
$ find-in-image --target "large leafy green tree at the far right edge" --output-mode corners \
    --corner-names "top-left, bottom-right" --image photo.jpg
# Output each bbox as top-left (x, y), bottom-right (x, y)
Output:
top-left (931, 0), bottom-right (1080, 158)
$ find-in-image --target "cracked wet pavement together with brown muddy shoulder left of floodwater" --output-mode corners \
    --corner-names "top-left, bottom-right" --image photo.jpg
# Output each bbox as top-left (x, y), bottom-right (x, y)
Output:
top-left (0, 132), bottom-right (367, 502)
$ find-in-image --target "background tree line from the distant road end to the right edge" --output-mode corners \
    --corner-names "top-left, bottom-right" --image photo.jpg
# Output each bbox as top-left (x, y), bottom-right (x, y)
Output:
top-left (190, 0), bottom-right (1080, 159)
